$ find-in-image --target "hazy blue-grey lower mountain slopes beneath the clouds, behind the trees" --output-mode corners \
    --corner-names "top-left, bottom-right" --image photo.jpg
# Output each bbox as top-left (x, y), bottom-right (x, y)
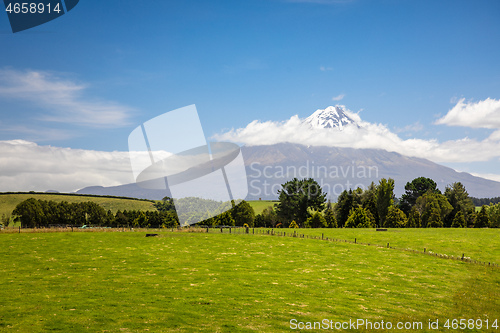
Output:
top-left (77, 143), bottom-right (500, 200)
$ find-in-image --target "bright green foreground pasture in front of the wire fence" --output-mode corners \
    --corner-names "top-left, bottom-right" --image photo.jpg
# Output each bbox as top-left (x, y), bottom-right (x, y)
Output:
top-left (0, 232), bottom-right (500, 332)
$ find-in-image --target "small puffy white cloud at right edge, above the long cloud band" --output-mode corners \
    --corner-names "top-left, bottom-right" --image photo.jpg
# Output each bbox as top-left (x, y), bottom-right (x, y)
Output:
top-left (436, 98), bottom-right (500, 129)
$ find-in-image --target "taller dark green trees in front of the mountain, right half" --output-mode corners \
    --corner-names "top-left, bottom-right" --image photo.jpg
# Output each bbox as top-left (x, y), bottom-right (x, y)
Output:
top-left (255, 177), bottom-right (500, 228)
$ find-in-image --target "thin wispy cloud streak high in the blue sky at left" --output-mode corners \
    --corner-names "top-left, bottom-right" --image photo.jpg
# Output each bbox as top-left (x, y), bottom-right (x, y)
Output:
top-left (0, 69), bottom-right (132, 128)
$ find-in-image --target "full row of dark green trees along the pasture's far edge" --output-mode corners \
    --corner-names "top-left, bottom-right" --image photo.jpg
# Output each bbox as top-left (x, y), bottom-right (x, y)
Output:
top-left (4, 177), bottom-right (500, 228)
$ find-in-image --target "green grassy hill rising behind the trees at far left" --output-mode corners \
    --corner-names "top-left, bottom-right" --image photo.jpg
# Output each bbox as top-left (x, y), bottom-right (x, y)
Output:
top-left (0, 193), bottom-right (156, 216)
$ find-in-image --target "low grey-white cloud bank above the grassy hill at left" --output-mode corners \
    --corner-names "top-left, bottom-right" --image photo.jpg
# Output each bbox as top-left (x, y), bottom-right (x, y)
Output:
top-left (0, 140), bottom-right (134, 192)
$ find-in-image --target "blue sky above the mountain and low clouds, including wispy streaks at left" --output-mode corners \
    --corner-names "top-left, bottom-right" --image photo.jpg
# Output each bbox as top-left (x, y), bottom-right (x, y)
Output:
top-left (0, 0), bottom-right (500, 190)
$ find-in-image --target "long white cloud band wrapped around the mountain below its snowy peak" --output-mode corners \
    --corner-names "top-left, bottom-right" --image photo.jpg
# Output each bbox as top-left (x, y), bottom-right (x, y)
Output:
top-left (214, 106), bottom-right (500, 162)
